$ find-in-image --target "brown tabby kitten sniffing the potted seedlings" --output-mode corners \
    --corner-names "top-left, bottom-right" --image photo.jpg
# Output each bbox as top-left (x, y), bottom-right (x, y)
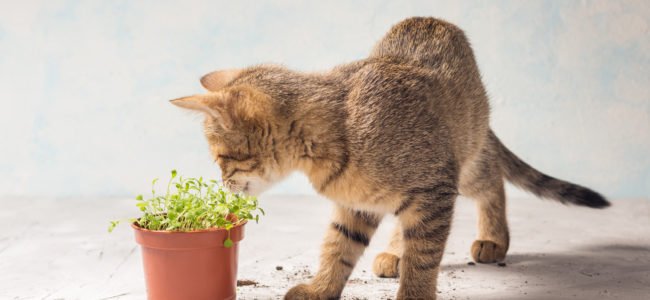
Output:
top-left (172, 17), bottom-right (609, 299)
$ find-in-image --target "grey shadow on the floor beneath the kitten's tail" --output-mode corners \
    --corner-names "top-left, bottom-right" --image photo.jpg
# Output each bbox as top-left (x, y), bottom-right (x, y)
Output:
top-left (442, 244), bottom-right (650, 299)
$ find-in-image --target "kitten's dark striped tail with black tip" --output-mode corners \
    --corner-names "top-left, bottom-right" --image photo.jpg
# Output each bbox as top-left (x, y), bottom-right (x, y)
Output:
top-left (490, 130), bottom-right (610, 208)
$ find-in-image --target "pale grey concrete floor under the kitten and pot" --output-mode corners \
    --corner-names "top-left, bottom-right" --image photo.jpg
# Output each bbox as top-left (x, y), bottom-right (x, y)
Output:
top-left (0, 196), bottom-right (650, 300)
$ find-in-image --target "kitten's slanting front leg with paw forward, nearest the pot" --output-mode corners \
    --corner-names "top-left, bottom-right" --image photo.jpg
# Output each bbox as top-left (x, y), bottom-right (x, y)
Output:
top-left (284, 206), bottom-right (381, 300)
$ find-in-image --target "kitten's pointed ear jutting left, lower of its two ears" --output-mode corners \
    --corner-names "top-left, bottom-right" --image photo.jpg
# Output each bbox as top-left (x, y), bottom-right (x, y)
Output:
top-left (169, 93), bottom-right (234, 129)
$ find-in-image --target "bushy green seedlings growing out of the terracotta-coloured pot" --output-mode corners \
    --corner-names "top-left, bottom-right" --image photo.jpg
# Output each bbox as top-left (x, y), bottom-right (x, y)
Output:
top-left (108, 170), bottom-right (264, 248)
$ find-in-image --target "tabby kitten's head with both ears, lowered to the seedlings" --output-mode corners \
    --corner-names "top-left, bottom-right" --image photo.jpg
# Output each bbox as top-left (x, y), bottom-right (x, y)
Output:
top-left (171, 70), bottom-right (290, 195)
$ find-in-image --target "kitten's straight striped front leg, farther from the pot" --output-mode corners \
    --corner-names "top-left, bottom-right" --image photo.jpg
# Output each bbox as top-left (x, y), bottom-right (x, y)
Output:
top-left (397, 182), bottom-right (458, 300)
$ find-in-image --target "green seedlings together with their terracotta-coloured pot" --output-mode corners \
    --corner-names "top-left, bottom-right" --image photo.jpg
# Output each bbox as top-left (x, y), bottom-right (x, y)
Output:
top-left (109, 170), bottom-right (264, 300)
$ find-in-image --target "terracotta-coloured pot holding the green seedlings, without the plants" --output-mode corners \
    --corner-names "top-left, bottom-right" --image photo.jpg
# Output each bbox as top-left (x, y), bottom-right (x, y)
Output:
top-left (131, 222), bottom-right (246, 300)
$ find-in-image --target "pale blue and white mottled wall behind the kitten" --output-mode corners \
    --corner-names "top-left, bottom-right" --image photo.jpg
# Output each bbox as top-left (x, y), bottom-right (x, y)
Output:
top-left (0, 0), bottom-right (650, 197)
